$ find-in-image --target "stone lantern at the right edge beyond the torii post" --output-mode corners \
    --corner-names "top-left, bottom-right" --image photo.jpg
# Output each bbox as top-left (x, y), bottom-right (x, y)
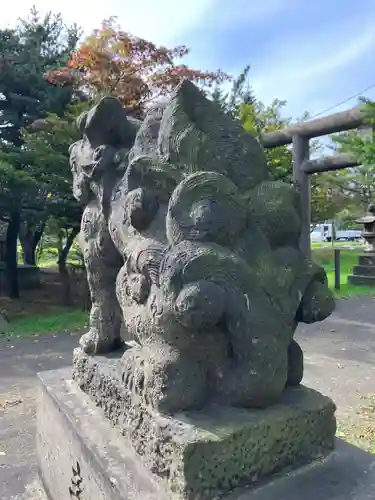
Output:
top-left (348, 203), bottom-right (375, 286)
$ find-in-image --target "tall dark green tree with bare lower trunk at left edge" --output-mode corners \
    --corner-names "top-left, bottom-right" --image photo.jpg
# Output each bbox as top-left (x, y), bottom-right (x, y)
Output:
top-left (0, 9), bottom-right (79, 298)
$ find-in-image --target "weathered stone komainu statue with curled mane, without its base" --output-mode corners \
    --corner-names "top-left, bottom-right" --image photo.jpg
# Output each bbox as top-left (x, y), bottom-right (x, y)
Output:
top-left (70, 81), bottom-right (334, 413)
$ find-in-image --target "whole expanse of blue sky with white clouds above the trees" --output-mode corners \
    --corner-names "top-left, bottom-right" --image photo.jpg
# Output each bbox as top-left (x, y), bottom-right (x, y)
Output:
top-left (0, 0), bottom-right (375, 118)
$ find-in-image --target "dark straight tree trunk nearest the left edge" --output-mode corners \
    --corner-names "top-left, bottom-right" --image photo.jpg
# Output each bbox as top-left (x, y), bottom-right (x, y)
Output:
top-left (5, 210), bottom-right (21, 299)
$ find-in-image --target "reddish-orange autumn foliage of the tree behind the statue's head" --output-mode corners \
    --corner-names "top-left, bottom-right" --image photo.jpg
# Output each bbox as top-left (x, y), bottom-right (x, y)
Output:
top-left (47, 18), bottom-right (229, 115)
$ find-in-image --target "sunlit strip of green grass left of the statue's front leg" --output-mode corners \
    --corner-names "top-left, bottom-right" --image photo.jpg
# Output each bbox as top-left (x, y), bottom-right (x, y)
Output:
top-left (3, 309), bottom-right (88, 337)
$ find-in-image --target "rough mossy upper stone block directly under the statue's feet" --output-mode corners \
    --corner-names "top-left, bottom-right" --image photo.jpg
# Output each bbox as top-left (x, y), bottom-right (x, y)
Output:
top-left (73, 349), bottom-right (336, 500)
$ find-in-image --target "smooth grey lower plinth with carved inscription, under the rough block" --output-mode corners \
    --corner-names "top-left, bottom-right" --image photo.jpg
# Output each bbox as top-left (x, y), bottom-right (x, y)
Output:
top-left (38, 368), bottom-right (375, 500)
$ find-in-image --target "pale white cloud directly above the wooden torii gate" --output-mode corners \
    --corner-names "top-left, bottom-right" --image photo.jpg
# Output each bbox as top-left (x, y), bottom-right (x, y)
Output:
top-left (251, 24), bottom-right (375, 116)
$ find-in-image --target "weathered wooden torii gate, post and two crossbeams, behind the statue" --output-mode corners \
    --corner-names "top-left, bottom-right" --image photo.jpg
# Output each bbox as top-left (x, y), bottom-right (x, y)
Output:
top-left (261, 107), bottom-right (372, 256)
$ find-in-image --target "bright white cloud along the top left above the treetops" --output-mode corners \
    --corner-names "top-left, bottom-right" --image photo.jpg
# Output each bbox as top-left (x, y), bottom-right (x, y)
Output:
top-left (0, 0), bottom-right (293, 45)
